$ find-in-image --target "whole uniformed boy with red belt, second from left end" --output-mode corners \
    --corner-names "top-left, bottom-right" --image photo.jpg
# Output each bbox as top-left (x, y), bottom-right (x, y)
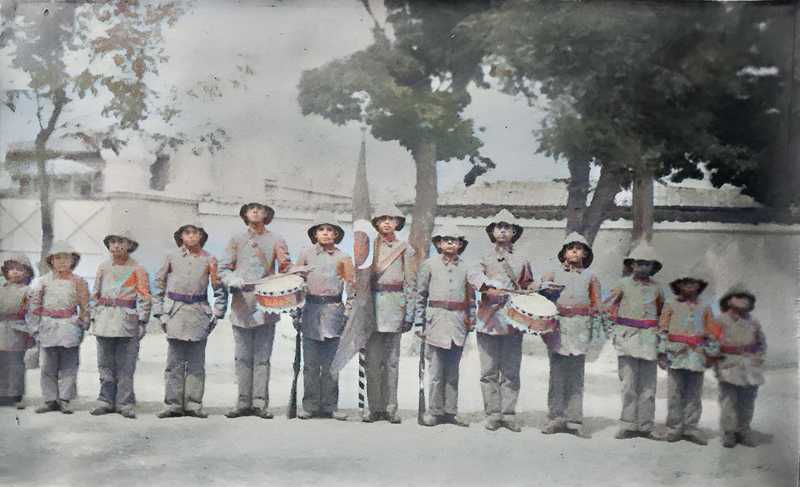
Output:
top-left (29, 242), bottom-right (89, 414)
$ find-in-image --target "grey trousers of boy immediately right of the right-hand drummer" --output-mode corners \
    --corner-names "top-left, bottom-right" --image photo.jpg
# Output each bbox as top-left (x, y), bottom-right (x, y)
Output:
top-left (547, 351), bottom-right (586, 424)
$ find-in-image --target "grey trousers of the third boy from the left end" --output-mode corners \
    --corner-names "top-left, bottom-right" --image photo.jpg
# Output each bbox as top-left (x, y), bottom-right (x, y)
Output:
top-left (97, 337), bottom-right (139, 411)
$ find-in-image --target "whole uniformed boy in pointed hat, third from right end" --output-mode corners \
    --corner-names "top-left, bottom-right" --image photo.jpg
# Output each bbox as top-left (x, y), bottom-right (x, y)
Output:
top-left (607, 242), bottom-right (664, 439)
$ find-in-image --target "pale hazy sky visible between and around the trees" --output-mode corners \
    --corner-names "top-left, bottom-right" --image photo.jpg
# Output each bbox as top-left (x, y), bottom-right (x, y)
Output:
top-left (0, 0), bottom-right (567, 199)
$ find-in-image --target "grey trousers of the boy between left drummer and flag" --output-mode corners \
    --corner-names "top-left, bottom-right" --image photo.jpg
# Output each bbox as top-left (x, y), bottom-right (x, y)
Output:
top-left (303, 336), bottom-right (339, 414)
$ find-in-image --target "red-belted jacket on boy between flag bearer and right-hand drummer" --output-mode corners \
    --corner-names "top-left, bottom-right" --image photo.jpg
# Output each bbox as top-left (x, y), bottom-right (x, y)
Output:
top-left (414, 255), bottom-right (475, 349)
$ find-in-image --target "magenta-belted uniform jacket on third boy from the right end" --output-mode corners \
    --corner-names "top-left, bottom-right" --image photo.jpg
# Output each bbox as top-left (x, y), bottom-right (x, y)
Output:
top-left (609, 277), bottom-right (664, 360)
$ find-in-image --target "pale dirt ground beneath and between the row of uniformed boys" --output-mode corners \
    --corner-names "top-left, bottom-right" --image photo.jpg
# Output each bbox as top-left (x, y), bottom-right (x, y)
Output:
top-left (0, 322), bottom-right (798, 487)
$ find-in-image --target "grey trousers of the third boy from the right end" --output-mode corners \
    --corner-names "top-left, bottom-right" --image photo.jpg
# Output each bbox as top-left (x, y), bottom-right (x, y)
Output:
top-left (618, 356), bottom-right (658, 432)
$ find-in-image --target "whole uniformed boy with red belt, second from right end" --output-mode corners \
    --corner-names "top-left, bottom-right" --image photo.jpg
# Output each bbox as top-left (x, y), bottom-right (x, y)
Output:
top-left (658, 277), bottom-right (718, 445)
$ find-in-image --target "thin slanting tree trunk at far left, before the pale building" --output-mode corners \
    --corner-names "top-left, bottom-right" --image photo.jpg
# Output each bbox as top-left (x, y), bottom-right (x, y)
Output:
top-left (35, 88), bottom-right (69, 273)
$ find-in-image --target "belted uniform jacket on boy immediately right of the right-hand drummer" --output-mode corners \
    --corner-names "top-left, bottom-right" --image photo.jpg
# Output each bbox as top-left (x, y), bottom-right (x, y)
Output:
top-left (545, 266), bottom-right (601, 355)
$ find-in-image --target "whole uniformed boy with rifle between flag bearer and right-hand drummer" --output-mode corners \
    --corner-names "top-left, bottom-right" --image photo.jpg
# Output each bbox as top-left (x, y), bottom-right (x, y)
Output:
top-left (414, 225), bottom-right (475, 427)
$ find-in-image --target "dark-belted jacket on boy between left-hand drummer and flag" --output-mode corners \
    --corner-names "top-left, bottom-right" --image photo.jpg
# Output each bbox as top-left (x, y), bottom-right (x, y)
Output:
top-left (297, 244), bottom-right (355, 341)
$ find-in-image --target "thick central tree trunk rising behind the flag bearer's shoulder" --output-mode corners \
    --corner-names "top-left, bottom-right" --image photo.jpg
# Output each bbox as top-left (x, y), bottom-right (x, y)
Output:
top-left (408, 142), bottom-right (439, 270)
